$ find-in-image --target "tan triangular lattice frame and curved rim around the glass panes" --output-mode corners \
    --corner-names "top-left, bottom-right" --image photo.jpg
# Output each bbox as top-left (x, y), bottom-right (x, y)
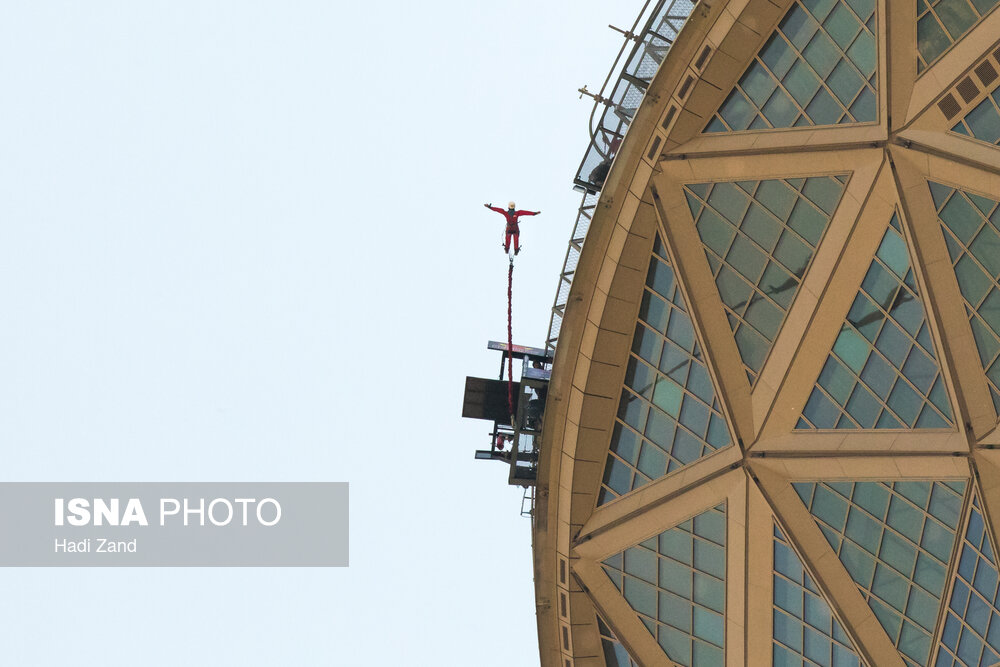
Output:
top-left (533, 0), bottom-right (1000, 667)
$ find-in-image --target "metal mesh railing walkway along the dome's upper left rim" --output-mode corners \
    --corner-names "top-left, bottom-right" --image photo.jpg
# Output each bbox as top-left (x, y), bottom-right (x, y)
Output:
top-left (545, 0), bottom-right (697, 349)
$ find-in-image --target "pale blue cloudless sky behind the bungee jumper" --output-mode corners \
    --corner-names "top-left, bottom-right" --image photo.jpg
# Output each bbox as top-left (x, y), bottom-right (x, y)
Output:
top-left (0, 0), bottom-right (628, 666)
